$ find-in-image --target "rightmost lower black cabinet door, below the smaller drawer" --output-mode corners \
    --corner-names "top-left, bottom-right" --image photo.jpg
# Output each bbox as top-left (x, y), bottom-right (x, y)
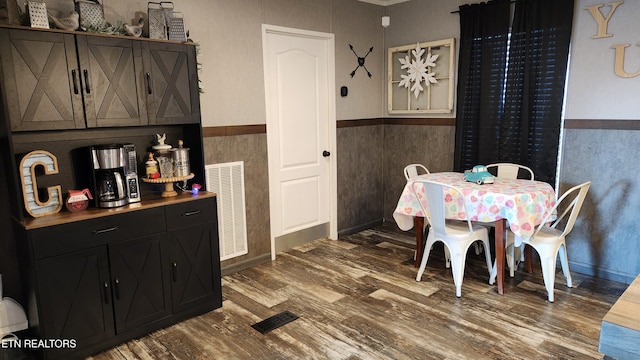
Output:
top-left (169, 223), bottom-right (222, 313)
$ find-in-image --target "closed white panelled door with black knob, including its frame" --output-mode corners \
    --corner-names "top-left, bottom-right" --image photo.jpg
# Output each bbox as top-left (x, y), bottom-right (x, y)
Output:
top-left (262, 25), bottom-right (337, 258)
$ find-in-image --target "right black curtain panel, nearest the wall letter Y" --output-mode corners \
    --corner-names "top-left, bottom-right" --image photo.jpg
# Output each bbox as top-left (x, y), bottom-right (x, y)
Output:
top-left (502, 0), bottom-right (574, 184)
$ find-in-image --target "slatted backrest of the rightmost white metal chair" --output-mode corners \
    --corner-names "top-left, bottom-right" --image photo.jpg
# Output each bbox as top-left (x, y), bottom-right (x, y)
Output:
top-left (533, 181), bottom-right (591, 237)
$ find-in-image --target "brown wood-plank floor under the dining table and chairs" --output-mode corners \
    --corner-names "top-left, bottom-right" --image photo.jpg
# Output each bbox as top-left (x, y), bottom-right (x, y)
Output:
top-left (92, 226), bottom-right (626, 360)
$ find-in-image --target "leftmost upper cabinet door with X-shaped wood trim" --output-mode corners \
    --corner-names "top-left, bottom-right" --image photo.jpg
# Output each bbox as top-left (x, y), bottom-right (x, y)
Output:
top-left (0, 29), bottom-right (85, 131)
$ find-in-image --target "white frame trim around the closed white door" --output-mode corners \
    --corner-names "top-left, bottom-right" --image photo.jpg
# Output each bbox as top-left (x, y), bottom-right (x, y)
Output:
top-left (262, 24), bottom-right (338, 260)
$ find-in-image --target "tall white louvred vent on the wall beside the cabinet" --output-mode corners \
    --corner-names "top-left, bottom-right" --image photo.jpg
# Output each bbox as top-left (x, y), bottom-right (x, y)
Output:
top-left (205, 161), bottom-right (247, 260)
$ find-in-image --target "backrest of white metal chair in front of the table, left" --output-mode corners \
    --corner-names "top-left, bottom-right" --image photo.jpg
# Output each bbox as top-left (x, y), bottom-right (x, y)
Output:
top-left (411, 180), bottom-right (473, 236)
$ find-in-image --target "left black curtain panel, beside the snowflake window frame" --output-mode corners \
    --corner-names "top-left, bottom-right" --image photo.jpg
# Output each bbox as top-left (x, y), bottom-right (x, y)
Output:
top-left (454, 0), bottom-right (510, 171)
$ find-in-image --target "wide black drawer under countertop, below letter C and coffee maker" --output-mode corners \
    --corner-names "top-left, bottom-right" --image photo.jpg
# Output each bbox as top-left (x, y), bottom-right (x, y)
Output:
top-left (30, 208), bottom-right (166, 259)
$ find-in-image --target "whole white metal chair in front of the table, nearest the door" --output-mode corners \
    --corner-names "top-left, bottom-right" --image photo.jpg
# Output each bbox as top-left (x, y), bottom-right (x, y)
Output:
top-left (411, 180), bottom-right (491, 297)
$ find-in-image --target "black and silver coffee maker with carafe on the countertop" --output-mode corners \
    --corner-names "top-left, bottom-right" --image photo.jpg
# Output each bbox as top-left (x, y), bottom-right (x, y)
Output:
top-left (89, 144), bottom-right (129, 208)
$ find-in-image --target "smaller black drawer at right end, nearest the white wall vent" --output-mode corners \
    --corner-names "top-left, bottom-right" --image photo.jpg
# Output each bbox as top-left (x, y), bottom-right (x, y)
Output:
top-left (165, 197), bottom-right (218, 231)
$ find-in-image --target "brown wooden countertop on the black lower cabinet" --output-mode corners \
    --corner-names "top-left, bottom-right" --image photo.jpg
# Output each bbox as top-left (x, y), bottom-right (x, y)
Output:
top-left (18, 191), bottom-right (216, 230)
